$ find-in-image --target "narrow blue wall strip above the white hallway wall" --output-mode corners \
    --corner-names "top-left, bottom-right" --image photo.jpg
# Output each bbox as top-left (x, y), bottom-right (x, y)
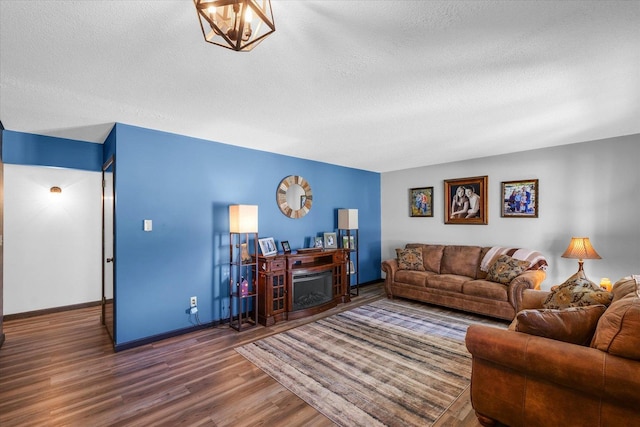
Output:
top-left (2, 130), bottom-right (102, 171)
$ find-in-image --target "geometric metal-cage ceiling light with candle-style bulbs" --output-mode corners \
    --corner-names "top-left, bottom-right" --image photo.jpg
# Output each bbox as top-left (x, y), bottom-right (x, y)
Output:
top-left (193, 0), bottom-right (276, 52)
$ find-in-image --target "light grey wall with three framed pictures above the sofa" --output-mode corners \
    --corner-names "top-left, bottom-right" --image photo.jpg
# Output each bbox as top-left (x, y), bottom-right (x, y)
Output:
top-left (381, 134), bottom-right (640, 289)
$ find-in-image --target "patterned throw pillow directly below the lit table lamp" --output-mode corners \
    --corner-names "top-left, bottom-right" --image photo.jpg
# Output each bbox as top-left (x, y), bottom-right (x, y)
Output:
top-left (542, 277), bottom-right (613, 309)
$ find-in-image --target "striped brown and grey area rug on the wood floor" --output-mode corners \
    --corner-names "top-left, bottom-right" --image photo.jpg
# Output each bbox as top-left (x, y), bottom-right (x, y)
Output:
top-left (236, 299), bottom-right (506, 426)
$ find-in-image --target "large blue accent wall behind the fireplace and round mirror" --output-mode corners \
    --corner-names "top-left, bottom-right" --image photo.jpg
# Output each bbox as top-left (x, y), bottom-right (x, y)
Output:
top-left (115, 123), bottom-right (381, 345)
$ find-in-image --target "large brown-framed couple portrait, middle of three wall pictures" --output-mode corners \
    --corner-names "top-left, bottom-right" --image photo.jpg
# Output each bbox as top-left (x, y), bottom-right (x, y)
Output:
top-left (444, 175), bottom-right (489, 225)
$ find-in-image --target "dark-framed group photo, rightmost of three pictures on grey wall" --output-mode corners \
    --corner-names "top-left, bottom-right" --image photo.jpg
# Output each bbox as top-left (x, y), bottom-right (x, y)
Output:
top-left (500, 179), bottom-right (540, 218)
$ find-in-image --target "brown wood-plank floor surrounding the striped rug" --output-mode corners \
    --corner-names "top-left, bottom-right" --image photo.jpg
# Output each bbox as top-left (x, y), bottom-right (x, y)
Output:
top-left (0, 284), bottom-right (480, 427)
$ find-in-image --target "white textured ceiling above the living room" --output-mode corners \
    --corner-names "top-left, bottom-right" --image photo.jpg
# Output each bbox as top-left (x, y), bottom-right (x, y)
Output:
top-left (0, 0), bottom-right (640, 172)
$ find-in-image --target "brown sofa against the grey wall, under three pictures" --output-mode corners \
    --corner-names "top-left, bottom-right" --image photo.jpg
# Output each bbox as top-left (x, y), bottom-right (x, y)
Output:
top-left (382, 243), bottom-right (546, 320)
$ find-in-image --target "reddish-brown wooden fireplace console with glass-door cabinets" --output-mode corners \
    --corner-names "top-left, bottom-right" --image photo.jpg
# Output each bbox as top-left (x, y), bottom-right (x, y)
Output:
top-left (252, 249), bottom-right (350, 326)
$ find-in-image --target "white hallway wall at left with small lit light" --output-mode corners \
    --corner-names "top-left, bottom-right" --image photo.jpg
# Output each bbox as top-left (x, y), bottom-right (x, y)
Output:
top-left (4, 164), bottom-right (102, 315)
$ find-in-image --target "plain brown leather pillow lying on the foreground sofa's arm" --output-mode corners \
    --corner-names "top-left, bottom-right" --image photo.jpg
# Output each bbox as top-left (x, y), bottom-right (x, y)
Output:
top-left (514, 305), bottom-right (606, 345)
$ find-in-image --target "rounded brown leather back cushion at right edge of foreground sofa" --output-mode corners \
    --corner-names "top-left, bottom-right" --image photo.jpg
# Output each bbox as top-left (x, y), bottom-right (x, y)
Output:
top-left (591, 297), bottom-right (640, 360)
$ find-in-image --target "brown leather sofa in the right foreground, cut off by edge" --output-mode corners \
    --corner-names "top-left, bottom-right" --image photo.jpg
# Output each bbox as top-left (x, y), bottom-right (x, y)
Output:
top-left (466, 278), bottom-right (640, 427)
